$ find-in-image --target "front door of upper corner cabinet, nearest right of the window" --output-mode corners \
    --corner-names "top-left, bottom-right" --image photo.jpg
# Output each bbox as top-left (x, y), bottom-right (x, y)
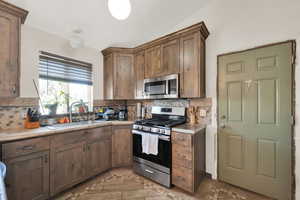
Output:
top-left (114, 53), bottom-right (135, 99)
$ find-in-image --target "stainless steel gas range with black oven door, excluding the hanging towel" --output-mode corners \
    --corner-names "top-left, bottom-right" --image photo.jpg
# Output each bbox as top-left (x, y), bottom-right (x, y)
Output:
top-left (132, 107), bottom-right (186, 187)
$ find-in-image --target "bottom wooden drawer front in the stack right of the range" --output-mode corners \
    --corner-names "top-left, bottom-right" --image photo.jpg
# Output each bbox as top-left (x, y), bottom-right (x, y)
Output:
top-left (172, 164), bottom-right (194, 193)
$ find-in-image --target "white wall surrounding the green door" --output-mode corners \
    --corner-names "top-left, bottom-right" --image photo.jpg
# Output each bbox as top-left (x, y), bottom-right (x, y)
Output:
top-left (164, 0), bottom-right (300, 199)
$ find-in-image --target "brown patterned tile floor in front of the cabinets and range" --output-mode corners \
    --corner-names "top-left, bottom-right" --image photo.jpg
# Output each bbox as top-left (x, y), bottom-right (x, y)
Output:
top-left (55, 169), bottom-right (269, 200)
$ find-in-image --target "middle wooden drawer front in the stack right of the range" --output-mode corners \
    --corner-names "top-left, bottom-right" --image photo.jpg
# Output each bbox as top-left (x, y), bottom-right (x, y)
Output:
top-left (172, 144), bottom-right (193, 169)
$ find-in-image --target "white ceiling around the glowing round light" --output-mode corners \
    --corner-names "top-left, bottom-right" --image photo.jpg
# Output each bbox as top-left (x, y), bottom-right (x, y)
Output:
top-left (7, 0), bottom-right (209, 50)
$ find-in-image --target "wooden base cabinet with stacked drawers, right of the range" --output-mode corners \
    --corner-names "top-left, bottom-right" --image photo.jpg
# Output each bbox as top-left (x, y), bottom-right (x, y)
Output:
top-left (171, 129), bottom-right (205, 193)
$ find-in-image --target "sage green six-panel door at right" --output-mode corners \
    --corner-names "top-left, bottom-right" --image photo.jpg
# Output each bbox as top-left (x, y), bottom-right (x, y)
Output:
top-left (218, 42), bottom-right (293, 200)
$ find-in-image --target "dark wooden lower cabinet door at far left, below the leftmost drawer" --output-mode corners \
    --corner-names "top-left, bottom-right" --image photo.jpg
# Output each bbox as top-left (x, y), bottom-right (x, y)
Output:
top-left (4, 151), bottom-right (49, 200)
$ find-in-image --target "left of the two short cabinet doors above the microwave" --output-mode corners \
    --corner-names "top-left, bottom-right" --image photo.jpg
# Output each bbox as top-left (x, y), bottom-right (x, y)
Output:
top-left (145, 45), bottom-right (163, 78)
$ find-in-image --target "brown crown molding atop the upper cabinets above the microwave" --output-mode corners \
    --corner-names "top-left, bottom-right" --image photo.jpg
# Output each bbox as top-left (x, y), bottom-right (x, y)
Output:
top-left (101, 21), bottom-right (209, 56)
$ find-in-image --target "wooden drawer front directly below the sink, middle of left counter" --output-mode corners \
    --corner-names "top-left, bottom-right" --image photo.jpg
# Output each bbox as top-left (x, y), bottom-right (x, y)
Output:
top-left (51, 130), bottom-right (88, 147)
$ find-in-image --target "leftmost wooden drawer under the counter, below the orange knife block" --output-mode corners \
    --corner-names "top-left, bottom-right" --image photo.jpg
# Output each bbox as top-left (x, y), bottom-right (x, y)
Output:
top-left (2, 137), bottom-right (50, 158)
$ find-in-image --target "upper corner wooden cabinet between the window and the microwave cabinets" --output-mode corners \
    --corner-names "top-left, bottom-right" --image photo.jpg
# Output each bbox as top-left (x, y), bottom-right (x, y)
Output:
top-left (103, 48), bottom-right (135, 100)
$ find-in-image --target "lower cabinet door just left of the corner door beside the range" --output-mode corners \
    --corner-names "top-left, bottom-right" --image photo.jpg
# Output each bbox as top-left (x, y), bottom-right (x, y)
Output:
top-left (86, 139), bottom-right (111, 177)
